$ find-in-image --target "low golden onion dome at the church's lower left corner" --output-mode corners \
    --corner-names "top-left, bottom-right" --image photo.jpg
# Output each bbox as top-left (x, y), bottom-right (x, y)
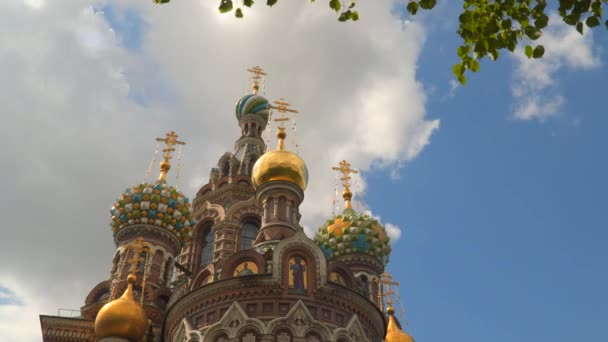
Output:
top-left (95, 274), bottom-right (148, 341)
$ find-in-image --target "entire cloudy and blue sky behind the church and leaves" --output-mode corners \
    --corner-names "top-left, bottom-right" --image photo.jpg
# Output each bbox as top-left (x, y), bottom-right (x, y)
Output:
top-left (0, 0), bottom-right (608, 342)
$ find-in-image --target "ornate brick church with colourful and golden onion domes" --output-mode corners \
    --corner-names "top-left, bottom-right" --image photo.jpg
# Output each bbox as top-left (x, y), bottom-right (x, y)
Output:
top-left (40, 67), bottom-right (413, 342)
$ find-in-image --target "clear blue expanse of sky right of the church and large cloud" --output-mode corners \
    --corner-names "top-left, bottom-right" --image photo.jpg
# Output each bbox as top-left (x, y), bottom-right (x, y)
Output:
top-left (366, 4), bottom-right (608, 342)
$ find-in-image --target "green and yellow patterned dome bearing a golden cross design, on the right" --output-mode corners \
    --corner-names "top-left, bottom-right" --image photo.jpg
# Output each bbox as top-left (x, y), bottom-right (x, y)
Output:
top-left (315, 209), bottom-right (391, 265)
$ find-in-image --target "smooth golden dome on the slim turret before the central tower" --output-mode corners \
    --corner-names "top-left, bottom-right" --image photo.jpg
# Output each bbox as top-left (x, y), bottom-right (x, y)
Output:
top-left (251, 128), bottom-right (308, 190)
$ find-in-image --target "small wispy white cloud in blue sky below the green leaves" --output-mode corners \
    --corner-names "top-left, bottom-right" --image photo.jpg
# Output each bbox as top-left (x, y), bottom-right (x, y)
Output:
top-left (512, 15), bottom-right (600, 121)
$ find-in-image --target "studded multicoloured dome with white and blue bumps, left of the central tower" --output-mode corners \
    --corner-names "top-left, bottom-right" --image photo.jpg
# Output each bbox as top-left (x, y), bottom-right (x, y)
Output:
top-left (110, 181), bottom-right (195, 245)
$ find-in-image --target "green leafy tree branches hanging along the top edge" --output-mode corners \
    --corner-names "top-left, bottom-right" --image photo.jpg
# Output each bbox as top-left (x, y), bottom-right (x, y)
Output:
top-left (154, 0), bottom-right (608, 85)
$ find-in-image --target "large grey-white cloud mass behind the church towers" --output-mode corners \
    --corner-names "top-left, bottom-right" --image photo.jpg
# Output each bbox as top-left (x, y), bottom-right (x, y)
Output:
top-left (0, 0), bottom-right (439, 341)
